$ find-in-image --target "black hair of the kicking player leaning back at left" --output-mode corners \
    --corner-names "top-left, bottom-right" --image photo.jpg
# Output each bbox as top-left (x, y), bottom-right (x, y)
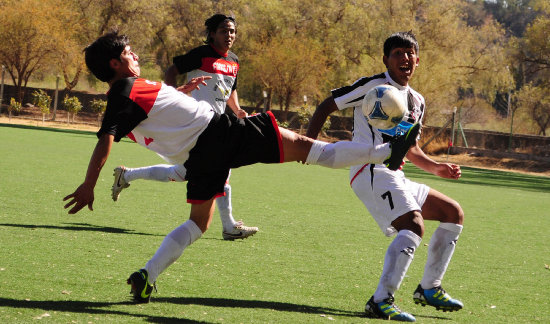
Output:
top-left (84, 31), bottom-right (129, 82)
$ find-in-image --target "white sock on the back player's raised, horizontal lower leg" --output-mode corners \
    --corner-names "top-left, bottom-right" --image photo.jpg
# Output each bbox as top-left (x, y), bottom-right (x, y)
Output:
top-left (124, 164), bottom-right (186, 182)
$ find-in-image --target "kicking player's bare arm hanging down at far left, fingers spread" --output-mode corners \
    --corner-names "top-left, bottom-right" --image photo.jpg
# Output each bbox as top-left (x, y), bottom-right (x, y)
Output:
top-left (63, 134), bottom-right (114, 214)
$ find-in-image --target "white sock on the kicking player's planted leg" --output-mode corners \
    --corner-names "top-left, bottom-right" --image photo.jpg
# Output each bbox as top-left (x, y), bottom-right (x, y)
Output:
top-left (144, 220), bottom-right (202, 284)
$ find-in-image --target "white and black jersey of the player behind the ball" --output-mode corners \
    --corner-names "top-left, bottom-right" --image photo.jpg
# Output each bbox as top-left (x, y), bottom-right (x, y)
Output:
top-left (332, 72), bottom-right (425, 177)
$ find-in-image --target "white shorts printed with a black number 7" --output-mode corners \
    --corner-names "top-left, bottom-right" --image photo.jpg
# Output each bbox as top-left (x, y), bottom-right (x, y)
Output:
top-left (350, 164), bottom-right (430, 236)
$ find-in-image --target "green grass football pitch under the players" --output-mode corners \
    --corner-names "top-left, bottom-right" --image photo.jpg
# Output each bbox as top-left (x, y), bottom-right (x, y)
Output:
top-left (0, 124), bottom-right (550, 323)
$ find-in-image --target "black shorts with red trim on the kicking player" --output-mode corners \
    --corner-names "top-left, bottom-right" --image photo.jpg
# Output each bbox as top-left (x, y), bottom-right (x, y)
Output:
top-left (183, 111), bottom-right (284, 204)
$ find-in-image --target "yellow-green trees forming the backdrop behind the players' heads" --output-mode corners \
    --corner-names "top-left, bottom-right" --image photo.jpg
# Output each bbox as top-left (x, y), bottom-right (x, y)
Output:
top-left (4, 0), bottom-right (550, 135)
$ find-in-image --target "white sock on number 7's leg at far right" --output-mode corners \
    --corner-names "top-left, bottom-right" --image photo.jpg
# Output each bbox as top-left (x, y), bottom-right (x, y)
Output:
top-left (420, 223), bottom-right (462, 289)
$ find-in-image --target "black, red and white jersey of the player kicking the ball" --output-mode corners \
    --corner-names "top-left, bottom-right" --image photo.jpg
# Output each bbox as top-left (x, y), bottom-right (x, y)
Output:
top-left (97, 78), bottom-right (215, 164)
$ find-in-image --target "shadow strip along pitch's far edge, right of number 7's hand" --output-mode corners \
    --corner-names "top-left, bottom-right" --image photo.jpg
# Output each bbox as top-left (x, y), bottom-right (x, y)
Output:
top-left (405, 165), bottom-right (550, 192)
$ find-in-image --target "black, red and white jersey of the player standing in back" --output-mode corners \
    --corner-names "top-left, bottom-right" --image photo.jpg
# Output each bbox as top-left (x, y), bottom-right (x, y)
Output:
top-left (173, 45), bottom-right (239, 114)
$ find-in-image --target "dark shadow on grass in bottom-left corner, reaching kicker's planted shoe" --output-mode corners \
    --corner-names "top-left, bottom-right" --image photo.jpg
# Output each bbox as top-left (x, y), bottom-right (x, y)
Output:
top-left (0, 297), bottom-right (209, 323)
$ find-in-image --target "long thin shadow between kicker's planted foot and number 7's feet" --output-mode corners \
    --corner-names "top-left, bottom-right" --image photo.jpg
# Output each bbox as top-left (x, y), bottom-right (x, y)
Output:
top-left (154, 297), bottom-right (363, 317)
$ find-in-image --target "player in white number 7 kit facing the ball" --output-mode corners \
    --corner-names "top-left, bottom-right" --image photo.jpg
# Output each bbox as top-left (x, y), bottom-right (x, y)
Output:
top-left (306, 32), bottom-right (464, 322)
